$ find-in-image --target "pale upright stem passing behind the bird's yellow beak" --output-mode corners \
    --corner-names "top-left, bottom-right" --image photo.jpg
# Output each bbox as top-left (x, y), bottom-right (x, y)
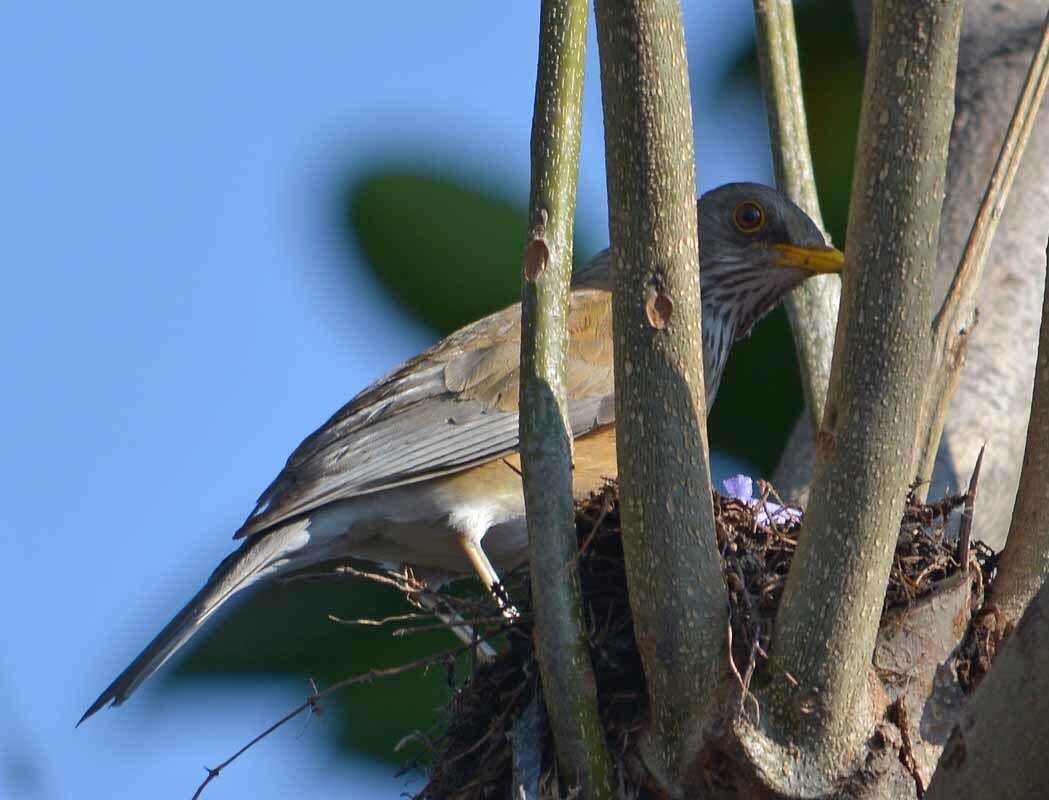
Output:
top-left (754, 0), bottom-right (841, 431)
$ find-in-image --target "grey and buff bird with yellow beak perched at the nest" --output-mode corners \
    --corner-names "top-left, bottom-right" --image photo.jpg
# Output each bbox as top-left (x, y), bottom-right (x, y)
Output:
top-left (78, 182), bottom-right (844, 726)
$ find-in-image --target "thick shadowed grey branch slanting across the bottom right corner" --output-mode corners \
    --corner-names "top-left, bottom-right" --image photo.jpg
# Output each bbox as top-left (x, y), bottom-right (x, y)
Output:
top-left (925, 584), bottom-right (1049, 800)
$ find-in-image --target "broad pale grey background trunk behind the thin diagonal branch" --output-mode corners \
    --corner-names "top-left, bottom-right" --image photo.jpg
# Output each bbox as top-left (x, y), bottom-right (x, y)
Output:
top-left (930, 0), bottom-right (1049, 548)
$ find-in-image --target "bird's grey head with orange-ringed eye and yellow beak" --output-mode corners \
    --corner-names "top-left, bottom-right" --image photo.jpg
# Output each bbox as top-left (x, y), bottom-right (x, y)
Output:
top-left (699, 183), bottom-right (844, 342)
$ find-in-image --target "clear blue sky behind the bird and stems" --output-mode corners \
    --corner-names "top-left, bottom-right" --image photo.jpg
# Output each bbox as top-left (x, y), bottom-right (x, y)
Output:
top-left (0, 2), bottom-right (769, 798)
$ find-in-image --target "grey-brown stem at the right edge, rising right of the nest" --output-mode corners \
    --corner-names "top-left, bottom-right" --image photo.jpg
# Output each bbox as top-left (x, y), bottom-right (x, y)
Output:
top-left (990, 238), bottom-right (1049, 623)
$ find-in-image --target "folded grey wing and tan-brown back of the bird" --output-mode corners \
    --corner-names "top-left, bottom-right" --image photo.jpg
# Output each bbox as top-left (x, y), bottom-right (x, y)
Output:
top-left (236, 278), bottom-right (615, 537)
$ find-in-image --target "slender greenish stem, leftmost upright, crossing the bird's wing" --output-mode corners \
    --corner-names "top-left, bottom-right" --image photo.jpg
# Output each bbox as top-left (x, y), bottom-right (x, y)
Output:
top-left (520, 0), bottom-right (615, 798)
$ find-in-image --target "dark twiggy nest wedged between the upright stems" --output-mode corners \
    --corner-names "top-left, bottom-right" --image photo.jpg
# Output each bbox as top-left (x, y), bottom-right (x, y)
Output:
top-left (418, 484), bottom-right (989, 800)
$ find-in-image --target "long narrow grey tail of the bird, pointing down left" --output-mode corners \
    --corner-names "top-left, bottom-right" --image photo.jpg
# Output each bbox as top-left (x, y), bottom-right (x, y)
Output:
top-left (77, 520), bottom-right (309, 726)
